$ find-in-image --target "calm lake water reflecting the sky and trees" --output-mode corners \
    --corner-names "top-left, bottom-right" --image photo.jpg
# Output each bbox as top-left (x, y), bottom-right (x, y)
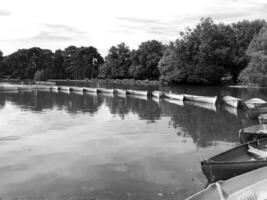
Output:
top-left (0, 83), bottom-right (267, 200)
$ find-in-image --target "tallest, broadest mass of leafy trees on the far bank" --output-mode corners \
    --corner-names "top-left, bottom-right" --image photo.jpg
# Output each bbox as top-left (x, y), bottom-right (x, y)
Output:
top-left (158, 18), bottom-right (265, 84)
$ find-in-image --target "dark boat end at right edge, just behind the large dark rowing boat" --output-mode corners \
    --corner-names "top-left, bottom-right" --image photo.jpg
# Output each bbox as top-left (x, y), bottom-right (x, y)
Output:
top-left (239, 124), bottom-right (267, 143)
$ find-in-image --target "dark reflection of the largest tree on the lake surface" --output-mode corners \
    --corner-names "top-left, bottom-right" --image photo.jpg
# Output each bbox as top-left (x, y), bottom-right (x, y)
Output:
top-left (160, 101), bottom-right (254, 146)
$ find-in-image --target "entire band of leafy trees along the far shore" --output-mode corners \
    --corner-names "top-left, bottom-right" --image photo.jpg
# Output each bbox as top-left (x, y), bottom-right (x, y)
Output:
top-left (0, 18), bottom-right (267, 85)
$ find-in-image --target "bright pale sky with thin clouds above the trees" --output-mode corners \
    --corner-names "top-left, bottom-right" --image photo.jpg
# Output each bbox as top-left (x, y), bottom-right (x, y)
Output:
top-left (0, 0), bottom-right (267, 56)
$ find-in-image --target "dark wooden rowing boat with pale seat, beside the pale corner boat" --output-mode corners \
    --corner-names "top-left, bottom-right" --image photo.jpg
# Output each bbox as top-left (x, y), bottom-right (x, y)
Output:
top-left (201, 138), bottom-right (267, 183)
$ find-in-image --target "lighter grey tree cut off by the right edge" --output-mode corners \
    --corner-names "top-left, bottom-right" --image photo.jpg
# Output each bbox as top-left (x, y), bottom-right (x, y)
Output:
top-left (239, 27), bottom-right (267, 86)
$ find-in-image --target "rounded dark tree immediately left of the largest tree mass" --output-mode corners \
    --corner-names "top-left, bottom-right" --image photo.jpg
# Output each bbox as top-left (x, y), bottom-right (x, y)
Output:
top-left (129, 40), bottom-right (164, 79)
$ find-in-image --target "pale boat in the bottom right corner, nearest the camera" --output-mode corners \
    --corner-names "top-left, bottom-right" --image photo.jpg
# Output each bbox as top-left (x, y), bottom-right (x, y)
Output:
top-left (186, 167), bottom-right (267, 200)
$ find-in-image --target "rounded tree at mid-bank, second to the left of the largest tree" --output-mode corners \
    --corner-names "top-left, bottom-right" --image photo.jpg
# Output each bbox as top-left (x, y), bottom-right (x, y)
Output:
top-left (103, 43), bottom-right (131, 79)
